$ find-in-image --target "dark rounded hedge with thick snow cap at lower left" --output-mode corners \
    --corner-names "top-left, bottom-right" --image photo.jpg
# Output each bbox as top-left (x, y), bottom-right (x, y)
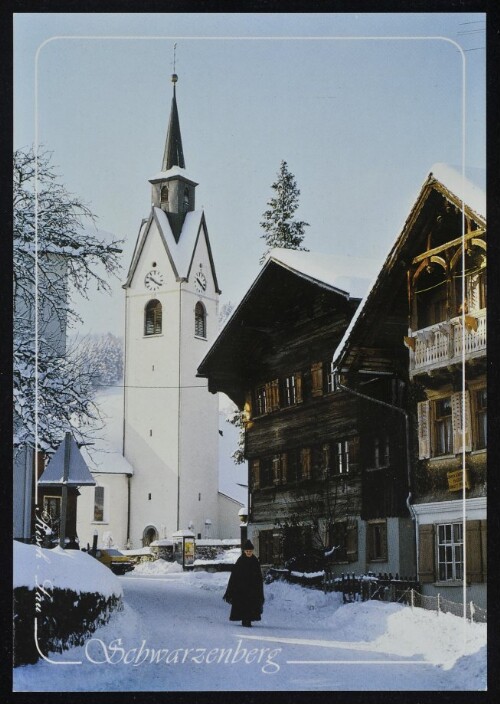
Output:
top-left (14, 541), bottom-right (123, 666)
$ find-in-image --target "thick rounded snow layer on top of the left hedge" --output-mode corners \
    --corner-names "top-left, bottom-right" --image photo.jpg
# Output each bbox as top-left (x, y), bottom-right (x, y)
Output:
top-left (13, 540), bottom-right (123, 597)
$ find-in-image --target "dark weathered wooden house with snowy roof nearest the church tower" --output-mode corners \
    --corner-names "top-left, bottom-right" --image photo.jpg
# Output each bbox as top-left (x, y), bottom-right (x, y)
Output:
top-left (198, 250), bottom-right (386, 572)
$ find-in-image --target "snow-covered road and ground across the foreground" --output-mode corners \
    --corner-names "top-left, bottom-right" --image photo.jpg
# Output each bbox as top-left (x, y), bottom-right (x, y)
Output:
top-left (14, 556), bottom-right (486, 692)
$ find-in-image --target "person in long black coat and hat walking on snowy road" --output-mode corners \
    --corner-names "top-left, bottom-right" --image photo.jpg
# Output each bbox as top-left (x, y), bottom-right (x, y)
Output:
top-left (222, 540), bottom-right (264, 626)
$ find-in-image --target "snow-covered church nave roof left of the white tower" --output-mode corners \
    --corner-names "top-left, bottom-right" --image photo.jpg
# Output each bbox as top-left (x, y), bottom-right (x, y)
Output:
top-left (81, 387), bottom-right (134, 474)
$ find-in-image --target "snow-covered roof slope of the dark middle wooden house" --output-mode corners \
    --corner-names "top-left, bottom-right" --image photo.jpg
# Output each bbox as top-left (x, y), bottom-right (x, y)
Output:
top-left (266, 248), bottom-right (377, 298)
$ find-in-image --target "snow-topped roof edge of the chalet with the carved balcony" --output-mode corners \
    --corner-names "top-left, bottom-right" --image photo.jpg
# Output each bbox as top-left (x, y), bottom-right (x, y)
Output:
top-left (332, 163), bottom-right (486, 366)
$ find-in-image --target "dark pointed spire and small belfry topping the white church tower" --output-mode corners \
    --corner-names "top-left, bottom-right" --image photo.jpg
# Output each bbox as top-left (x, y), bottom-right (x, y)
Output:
top-left (149, 73), bottom-right (198, 242)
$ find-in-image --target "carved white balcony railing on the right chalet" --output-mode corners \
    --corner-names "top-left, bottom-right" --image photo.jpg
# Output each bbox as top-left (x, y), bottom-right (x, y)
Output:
top-left (410, 309), bottom-right (486, 373)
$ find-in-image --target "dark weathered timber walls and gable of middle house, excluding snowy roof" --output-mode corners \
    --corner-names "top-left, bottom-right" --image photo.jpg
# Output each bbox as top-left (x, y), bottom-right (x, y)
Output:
top-left (199, 254), bottom-right (414, 574)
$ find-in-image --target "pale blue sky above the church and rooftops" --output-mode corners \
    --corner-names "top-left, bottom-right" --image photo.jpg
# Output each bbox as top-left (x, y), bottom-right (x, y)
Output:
top-left (14, 12), bottom-right (486, 334)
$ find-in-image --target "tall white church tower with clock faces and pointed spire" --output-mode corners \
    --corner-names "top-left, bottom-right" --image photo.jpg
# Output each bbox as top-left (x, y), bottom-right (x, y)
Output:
top-left (123, 74), bottom-right (220, 547)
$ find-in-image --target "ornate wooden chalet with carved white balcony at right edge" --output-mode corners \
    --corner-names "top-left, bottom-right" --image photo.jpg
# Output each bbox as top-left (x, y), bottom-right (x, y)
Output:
top-left (333, 165), bottom-right (487, 605)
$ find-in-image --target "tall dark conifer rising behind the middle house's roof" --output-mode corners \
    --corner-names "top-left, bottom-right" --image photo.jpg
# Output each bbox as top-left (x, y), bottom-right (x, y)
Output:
top-left (260, 161), bottom-right (309, 264)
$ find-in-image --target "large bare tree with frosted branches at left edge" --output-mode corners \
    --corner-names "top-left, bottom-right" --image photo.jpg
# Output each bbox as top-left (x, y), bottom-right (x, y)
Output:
top-left (14, 149), bottom-right (121, 453)
